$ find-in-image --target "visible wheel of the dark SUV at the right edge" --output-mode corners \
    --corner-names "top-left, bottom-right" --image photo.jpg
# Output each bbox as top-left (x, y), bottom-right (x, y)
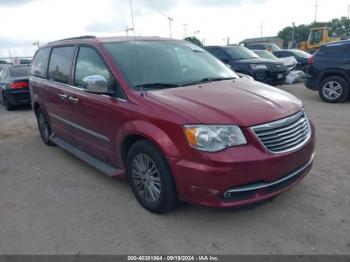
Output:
top-left (319, 76), bottom-right (349, 103)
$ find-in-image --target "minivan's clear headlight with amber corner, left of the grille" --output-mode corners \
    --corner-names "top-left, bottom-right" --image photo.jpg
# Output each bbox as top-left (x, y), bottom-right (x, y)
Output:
top-left (184, 125), bottom-right (247, 152)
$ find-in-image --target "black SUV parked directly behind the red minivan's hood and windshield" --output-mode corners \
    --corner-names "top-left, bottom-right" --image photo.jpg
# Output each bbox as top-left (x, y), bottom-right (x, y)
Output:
top-left (205, 45), bottom-right (287, 86)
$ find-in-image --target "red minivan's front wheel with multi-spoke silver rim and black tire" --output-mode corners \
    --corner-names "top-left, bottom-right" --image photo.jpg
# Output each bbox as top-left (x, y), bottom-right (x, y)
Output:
top-left (126, 140), bottom-right (178, 214)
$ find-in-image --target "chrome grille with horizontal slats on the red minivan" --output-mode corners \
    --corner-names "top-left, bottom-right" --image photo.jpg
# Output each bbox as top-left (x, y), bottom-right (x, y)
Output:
top-left (251, 111), bottom-right (311, 153)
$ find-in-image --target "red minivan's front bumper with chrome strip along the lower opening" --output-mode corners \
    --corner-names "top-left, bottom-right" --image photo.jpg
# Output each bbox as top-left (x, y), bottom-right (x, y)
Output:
top-left (169, 127), bottom-right (315, 208)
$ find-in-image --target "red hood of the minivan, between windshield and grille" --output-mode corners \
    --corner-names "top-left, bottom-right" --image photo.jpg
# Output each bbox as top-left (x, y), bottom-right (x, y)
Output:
top-left (147, 78), bottom-right (302, 127)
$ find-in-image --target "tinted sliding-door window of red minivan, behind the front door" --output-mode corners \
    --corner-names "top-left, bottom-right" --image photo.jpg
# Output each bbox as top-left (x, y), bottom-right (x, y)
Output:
top-left (49, 46), bottom-right (74, 84)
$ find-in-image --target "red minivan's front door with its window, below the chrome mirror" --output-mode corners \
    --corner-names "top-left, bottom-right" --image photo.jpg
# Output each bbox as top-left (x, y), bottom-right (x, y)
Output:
top-left (72, 46), bottom-right (127, 164)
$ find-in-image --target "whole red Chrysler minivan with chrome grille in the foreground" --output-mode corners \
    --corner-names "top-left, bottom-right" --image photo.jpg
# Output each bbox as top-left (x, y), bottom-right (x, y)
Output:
top-left (30, 36), bottom-right (315, 213)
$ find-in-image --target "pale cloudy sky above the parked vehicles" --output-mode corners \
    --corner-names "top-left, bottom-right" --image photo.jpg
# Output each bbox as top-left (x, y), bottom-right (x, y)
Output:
top-left (0, 0), bottom-right (350, 57)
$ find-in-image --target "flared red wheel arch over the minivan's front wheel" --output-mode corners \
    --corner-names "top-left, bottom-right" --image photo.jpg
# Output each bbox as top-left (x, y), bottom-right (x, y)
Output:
top-left (116, 120), bottom-right (181, 166)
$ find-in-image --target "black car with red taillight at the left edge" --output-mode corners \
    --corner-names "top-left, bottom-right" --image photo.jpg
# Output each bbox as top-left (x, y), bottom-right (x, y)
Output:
top-left (0, 65), bottom-right (30, 110)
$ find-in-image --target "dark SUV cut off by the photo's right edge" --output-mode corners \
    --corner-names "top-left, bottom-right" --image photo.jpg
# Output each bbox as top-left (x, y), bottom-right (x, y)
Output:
top-left (305, 40), bottom-right (350, 103)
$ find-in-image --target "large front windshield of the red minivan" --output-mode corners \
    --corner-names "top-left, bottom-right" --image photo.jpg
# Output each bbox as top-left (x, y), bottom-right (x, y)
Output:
top-left (104, 40), bottom-right (238, 88)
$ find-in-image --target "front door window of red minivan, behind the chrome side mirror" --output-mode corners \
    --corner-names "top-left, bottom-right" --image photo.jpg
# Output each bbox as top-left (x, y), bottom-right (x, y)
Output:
top-left (74, 47), bottom-right (125, 98)
